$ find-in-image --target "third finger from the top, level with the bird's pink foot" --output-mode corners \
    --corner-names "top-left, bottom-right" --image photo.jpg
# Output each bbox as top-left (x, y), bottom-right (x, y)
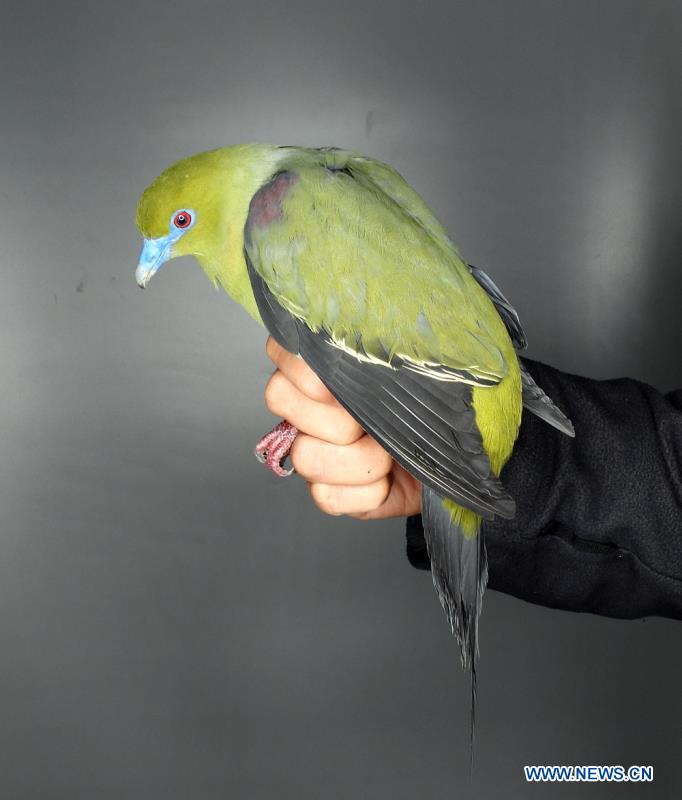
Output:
top-left (291, 434), bottom-right (393, 486)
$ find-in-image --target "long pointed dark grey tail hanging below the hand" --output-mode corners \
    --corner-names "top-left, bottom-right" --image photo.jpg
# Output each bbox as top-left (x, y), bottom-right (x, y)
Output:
top-left (422, 486), bottom-right (488, 764)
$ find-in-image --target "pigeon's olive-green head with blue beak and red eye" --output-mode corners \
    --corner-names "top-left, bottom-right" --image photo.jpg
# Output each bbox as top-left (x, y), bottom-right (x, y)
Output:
top-left (135, 150), bottom-right (225, 289)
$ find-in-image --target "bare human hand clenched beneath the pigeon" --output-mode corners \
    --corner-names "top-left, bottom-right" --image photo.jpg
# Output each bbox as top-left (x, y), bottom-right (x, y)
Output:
top-left (265, 337), bottom-right (421, 519)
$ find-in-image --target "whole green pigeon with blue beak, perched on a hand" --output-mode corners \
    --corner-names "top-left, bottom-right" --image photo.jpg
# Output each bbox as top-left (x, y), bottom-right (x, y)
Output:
top-left (136, 144), bottom-right (574, 752)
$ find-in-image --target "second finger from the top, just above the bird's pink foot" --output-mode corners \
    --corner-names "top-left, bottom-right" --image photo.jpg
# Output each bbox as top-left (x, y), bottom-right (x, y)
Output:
top-left (265, 370), bottom-right (364, 444)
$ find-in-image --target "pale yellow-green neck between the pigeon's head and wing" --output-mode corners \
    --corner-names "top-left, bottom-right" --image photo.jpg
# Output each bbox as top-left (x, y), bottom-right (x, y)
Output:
top-left (197, 145), bottom-right (288, 322)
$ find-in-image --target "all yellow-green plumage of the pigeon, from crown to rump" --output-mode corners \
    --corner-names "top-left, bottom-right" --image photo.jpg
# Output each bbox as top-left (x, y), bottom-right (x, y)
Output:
top-left (137, 145), bottom-right (521, 516)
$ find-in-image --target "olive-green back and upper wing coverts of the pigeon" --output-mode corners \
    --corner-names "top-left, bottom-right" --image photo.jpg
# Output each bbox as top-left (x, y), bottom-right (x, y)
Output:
top-left (247, 151), bottom-right (509, 388)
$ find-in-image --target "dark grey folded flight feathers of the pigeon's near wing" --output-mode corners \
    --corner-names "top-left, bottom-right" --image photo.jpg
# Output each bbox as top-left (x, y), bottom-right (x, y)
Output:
top-left (245, 253), bottom-right (515, 519)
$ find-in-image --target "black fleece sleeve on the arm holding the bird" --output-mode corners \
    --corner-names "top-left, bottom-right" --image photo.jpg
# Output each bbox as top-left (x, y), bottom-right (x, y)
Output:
top-left (407, 359), bottom-right (682, 619)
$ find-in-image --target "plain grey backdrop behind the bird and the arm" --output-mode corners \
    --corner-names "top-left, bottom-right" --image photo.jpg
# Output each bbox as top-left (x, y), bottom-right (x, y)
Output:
top-left (0, 0), bottom-right (682, 800)
